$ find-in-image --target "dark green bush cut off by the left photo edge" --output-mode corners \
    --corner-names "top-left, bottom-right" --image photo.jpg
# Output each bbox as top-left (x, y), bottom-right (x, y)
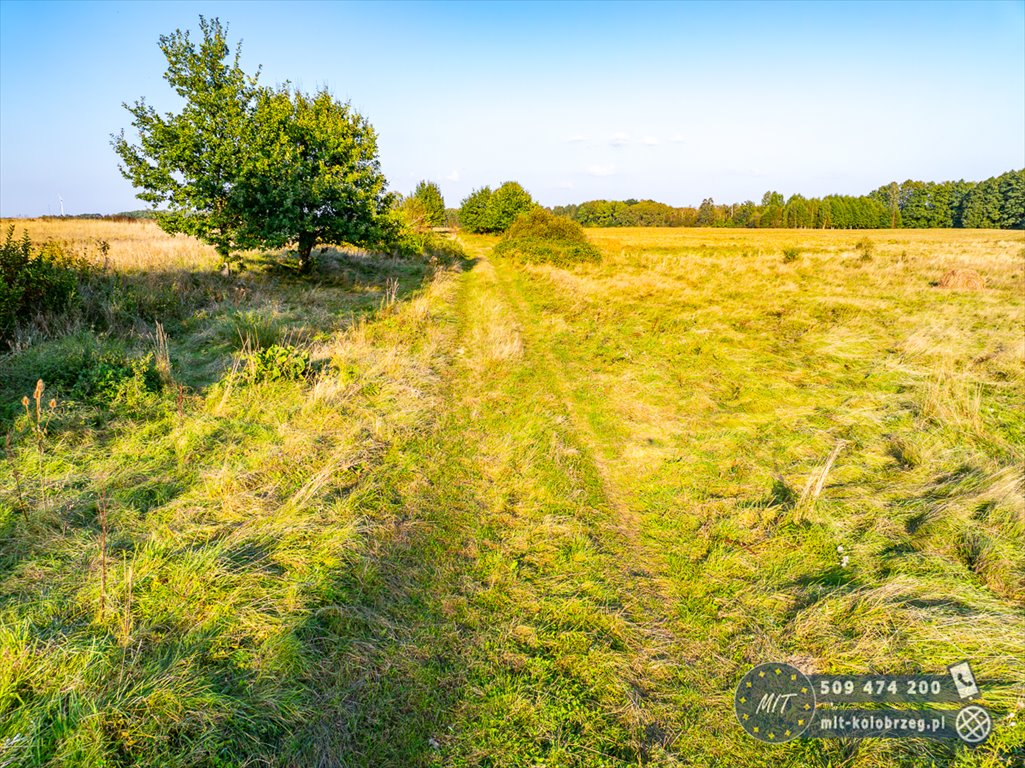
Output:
top-left (0, 225), bottom-right (86, 346)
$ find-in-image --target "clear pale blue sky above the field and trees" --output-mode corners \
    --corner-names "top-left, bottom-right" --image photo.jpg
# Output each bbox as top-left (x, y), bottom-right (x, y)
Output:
top-left (0, 0), bottom-right (1025, 216)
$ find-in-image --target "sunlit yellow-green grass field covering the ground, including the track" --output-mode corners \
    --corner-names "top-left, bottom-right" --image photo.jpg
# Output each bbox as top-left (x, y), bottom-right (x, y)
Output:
top-left (0, 221), bottom-right (1025, 768)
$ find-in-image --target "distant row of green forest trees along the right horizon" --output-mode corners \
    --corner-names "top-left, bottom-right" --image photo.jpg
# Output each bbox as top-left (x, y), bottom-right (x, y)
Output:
top-left (551, 169), bottom-right (1025, 230)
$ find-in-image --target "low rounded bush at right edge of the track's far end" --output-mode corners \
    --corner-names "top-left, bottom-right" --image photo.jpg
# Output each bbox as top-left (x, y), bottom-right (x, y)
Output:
top-left (495, 208), bottom-right (602, 267)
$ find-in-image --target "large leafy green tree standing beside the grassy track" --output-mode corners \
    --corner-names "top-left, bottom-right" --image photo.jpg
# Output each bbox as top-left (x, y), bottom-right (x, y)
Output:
top-left (113, 16), bottom-right (395, 272)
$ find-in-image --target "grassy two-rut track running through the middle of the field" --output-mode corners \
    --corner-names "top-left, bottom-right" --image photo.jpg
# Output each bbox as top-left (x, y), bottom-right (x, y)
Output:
top-left (387, 248), bottom-right (766, 765)
